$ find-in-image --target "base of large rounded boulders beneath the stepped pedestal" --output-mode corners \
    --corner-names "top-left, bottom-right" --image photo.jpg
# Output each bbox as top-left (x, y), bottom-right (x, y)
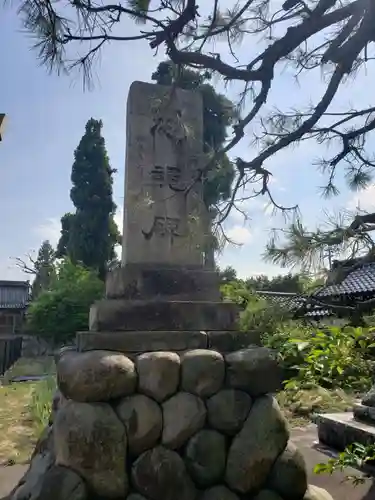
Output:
top-left (9, 347), bottom-right (331, 500)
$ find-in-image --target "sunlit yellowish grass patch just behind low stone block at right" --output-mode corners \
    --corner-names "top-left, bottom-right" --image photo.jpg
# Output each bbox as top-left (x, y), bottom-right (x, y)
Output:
top-left (277, 387), bottom-right (358, 426)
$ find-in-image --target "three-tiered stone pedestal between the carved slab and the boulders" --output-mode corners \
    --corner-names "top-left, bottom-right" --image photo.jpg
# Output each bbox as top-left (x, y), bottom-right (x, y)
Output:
top-left (77, 265), bottom-right (254, 356)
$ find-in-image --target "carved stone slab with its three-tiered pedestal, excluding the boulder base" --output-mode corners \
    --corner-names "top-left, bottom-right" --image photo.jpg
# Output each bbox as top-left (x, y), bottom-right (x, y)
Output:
top-left (77, 82), bottom-right (254, 353)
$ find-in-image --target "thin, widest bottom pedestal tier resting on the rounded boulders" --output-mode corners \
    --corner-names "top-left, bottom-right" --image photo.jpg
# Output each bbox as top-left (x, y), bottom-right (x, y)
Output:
top-left (77, 330), bottom-right (260, 354)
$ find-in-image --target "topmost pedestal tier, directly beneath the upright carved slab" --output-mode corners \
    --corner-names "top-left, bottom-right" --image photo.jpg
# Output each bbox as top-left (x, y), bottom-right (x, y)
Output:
top-left (106, 264), bottom-right (220, 302)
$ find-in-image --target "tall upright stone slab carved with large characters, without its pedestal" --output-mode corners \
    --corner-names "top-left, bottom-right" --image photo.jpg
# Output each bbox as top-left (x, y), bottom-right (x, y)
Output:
top-left (122, 82), bottom-right (205, 269)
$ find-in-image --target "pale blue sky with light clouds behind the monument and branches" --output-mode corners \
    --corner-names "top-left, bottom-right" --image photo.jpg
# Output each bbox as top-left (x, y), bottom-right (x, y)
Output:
top-left (0, 3), bottom-right (375, 279)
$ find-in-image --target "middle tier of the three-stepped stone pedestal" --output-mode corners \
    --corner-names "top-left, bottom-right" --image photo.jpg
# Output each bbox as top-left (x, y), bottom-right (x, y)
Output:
top-left (89, 299), bottom-right (239, 332)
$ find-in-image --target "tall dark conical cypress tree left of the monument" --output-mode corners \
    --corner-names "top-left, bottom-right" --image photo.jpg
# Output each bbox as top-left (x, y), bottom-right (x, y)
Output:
top-left (57, 118), bottom-right (119, 278)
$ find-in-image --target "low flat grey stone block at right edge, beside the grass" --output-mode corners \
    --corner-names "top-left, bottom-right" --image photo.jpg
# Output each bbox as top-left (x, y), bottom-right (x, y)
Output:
top-left (315, 412), bottom-right (375, 451)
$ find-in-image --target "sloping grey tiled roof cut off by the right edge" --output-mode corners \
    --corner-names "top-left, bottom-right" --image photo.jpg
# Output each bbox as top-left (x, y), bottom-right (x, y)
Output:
top-left (313, 262), bottom-right (375, 298)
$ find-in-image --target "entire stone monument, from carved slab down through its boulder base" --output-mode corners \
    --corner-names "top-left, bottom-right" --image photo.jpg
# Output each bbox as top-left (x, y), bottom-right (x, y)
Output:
top-left (9, 82), bottom-right (331, 500)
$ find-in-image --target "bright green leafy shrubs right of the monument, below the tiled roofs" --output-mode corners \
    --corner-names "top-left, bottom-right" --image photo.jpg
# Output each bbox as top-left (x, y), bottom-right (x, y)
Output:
top-left (221, 280), bottom-right (375, 392)
